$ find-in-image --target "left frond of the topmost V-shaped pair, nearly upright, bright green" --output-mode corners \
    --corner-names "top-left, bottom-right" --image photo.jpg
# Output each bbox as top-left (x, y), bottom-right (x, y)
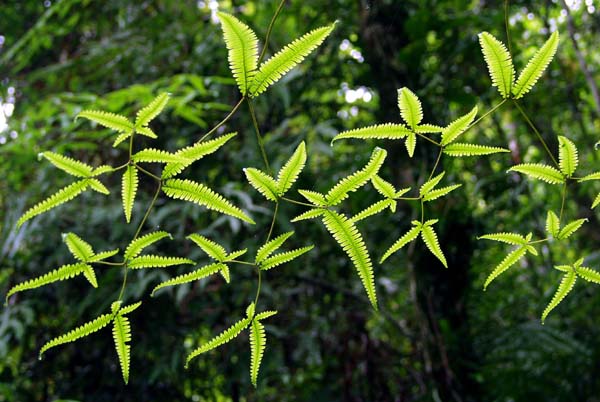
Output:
top-left (217, 12), bottom-right (258, 96)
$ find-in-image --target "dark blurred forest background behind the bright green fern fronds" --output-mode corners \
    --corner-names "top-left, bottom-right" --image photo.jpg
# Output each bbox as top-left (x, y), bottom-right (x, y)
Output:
top-left (0, 0), bottom-right (600, 402)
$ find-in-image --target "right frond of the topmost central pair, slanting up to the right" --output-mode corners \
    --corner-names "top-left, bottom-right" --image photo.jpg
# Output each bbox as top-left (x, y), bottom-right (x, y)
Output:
top-left (248, 23), bottom-right (335, 96)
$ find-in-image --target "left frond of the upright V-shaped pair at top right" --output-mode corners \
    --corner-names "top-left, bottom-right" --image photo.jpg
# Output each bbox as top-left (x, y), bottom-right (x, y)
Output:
top-left (479, 32), bottom-right (515, 99)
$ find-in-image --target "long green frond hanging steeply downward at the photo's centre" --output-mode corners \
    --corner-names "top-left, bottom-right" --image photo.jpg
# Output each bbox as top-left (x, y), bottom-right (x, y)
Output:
top-left (323, 210), bottom-right (377, 310)
